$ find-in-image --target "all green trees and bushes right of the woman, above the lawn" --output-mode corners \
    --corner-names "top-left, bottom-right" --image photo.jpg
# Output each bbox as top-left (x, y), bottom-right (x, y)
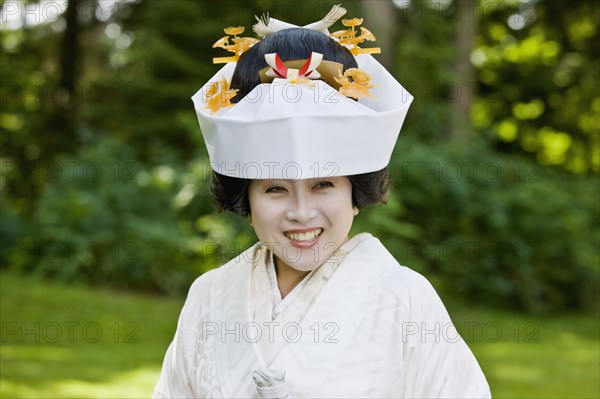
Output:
top-left (384, 1), bottom-right (600, 312)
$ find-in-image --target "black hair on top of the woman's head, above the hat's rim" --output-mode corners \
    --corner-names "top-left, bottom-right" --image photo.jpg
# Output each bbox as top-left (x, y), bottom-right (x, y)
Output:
top-left (231, 28), bottom-right (358, 103)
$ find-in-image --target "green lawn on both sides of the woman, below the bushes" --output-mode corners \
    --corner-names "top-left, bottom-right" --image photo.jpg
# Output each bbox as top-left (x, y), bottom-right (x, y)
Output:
top-left (0, 273), bottom-right (600, 398)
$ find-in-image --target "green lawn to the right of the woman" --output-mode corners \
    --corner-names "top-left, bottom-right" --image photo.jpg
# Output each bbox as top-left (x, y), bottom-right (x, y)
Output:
top-left (449, 305), bottom-right (600, 398)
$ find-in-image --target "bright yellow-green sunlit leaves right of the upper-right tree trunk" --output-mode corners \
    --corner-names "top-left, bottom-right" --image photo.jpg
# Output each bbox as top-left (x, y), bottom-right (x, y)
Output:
top-left (472, 1), bottom-right (600, 174)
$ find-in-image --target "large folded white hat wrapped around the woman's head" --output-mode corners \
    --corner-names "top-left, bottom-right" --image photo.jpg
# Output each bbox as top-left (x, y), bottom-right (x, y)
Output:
top-left (192, 12), bottom-right (413, 179)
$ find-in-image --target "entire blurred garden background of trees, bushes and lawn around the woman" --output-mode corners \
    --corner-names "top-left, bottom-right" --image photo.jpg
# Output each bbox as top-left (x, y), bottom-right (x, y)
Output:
top-left (0, 0), bottom-right (600, 398)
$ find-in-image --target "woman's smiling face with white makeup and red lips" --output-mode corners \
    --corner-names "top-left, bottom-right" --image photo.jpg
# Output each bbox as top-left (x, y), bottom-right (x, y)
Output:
top-left (248, 177), bottom-right (358, 271)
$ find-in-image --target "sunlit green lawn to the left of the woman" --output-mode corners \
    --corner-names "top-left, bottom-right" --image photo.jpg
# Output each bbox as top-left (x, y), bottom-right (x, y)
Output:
top-left (0, 273), bottom-right (183, 398)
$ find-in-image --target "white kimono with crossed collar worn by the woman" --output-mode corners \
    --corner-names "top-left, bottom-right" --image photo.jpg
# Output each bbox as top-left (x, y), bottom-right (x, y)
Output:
top-left (154, 233), bottom-right (491, 399)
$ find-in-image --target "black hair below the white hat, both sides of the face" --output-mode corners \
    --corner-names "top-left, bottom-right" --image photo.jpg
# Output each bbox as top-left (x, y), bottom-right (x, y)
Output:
top-left (210, 170), bottom-right (390, 216)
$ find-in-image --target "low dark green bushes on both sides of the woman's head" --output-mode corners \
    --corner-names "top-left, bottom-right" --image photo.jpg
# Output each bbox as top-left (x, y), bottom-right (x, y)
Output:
top-left (0, 136), bottom-right (600, 312)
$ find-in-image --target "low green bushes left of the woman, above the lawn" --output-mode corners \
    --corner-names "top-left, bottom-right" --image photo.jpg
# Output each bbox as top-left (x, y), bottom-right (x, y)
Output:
top-left (2, 138), bottom-right (252, 293)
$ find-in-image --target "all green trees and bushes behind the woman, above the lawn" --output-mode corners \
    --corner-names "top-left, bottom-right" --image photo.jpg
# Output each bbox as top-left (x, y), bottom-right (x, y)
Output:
top-left (0, 0), bottom-right (600, 312)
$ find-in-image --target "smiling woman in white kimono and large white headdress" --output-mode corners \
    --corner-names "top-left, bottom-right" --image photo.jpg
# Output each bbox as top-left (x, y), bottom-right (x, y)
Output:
top-left (154, 7), bottom-right (490, 398)
